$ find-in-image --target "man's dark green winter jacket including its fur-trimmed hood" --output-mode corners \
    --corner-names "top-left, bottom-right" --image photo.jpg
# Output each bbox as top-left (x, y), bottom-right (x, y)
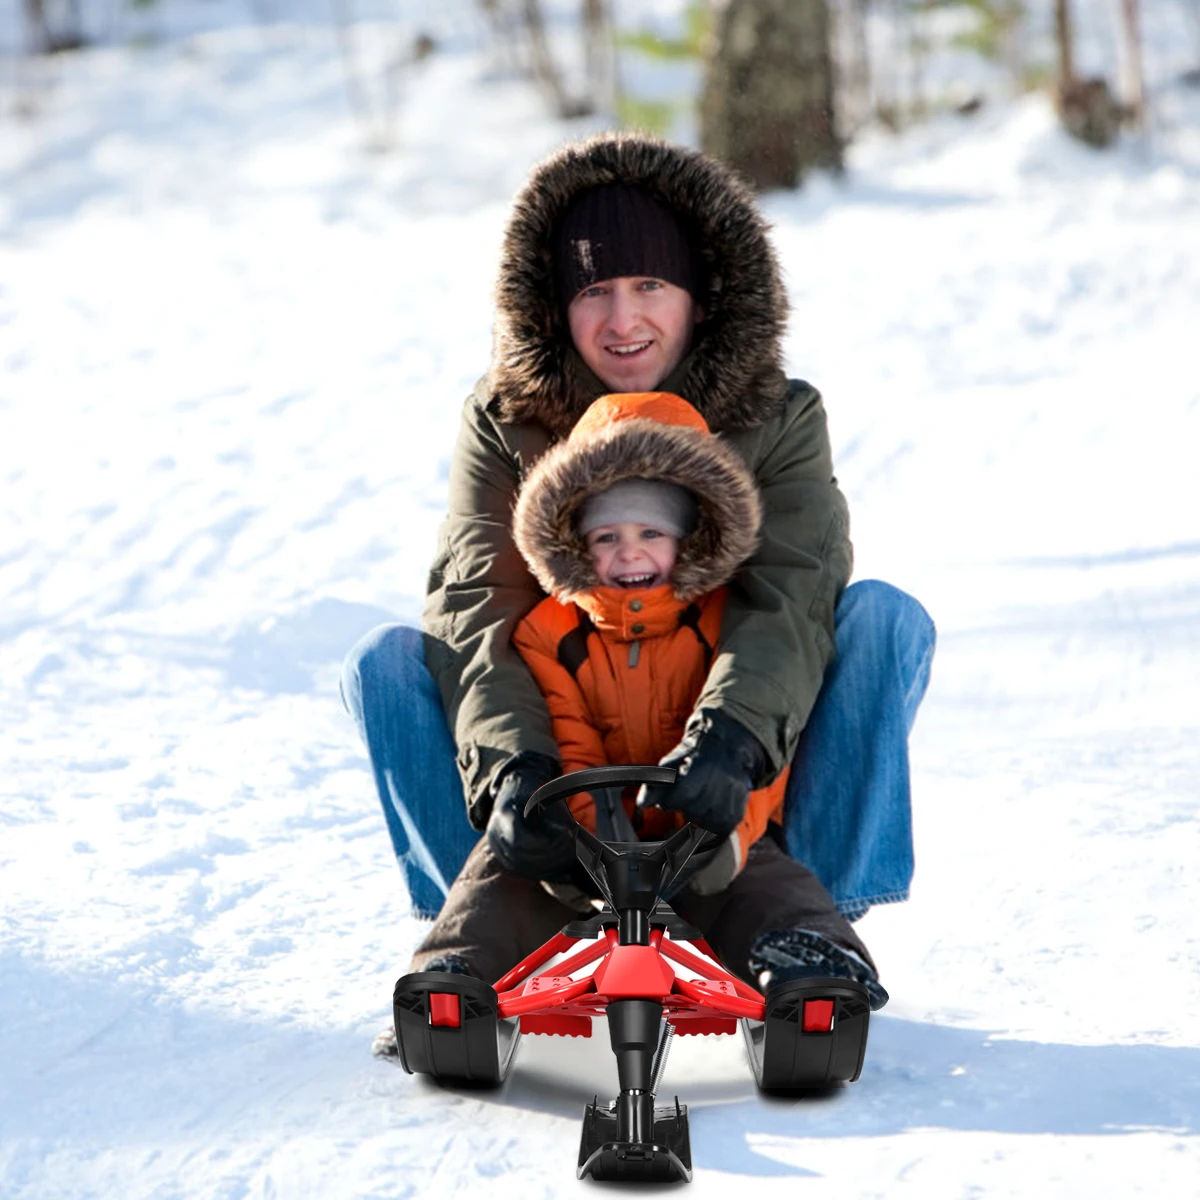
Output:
top-left (424, 134), bottom-right (852, 829)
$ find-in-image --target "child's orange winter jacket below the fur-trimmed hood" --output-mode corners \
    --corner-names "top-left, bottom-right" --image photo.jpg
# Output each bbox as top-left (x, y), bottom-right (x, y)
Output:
top-left (512, 584), bottom-right (787, 864)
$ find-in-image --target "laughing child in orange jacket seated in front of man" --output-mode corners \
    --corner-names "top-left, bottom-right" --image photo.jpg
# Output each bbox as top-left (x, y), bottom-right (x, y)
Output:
top-left (398, 392), bottom-right (887, 1008)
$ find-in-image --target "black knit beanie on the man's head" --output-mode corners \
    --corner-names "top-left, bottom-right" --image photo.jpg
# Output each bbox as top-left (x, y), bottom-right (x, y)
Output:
top-left (551, 184), bottom-right (701, 308)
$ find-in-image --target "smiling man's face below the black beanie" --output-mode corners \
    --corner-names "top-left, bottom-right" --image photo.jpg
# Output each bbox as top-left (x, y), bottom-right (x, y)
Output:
top-left (566, 275), bottom-right (701, 391)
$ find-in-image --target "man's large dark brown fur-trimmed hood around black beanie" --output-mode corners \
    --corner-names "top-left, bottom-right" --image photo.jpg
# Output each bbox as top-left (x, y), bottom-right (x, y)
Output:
top-left (488, 133), bottom-right (787, 437)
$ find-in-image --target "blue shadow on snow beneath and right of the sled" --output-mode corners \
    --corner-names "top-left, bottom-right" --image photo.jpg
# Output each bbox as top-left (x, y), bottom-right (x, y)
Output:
top-left (475, 1016), bottom-right (1200, 1156)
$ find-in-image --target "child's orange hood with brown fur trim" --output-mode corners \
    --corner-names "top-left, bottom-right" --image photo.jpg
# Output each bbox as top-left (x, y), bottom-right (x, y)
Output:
top-left (512, 392), bottom-right (762, 602)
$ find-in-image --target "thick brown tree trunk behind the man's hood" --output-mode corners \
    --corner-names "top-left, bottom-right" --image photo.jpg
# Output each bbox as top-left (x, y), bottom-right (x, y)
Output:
top-left (700, 0), bottom-right (841, 190)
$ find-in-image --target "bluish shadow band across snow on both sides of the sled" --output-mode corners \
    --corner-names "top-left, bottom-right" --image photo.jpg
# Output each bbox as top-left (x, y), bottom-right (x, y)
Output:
top-left (7, 953), bottom-right (1200, 1194)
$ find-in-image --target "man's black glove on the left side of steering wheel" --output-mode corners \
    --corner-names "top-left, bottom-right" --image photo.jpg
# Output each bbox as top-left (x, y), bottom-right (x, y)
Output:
top-left (486, 751), bottom-right (576, 883)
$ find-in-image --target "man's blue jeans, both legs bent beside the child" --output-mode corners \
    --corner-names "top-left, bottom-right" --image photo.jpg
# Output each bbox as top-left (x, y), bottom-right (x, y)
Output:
top-left (342, 580), bottom-right (935, 920)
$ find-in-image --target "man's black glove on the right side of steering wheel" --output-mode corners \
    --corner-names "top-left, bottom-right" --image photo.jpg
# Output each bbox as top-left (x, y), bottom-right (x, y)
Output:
top-left (637, 709), bottom-right (769, 838)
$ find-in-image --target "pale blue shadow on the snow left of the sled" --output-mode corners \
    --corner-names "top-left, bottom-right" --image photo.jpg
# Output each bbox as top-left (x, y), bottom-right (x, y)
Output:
top-left (0, 952), bottom-right (373, 1142)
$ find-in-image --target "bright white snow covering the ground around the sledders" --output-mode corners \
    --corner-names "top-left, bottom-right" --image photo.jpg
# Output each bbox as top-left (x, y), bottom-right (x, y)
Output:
top-left (0, 4), bottom-right (1200, 1200)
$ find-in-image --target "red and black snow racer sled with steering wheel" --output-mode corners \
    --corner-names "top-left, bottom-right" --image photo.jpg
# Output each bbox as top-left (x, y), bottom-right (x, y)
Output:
top-left (394, 767), bottom-right (870, 1182)
